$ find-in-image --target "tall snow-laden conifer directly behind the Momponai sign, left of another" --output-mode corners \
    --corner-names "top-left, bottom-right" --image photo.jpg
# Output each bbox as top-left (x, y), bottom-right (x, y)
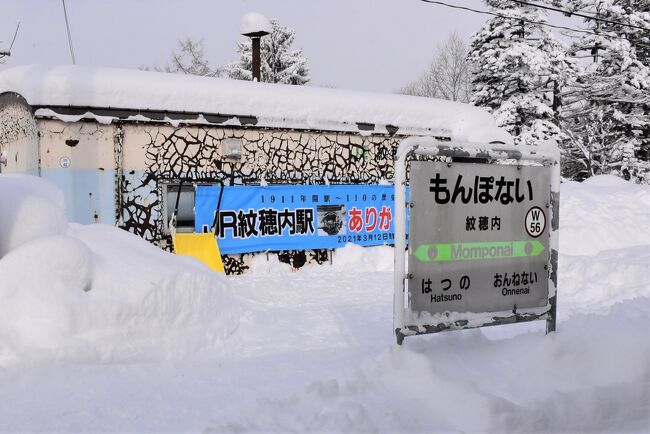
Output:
top-left (469, 0), bottom-right (570, 147)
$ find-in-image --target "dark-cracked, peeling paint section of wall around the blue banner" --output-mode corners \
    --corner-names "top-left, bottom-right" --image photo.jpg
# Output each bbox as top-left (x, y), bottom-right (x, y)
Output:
top-left (116, 124), bottom-right (401, 272)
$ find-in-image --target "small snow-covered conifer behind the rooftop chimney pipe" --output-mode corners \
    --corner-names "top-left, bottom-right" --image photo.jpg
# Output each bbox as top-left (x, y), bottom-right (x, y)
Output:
top-left (226, 20), bottom-right (310, 84)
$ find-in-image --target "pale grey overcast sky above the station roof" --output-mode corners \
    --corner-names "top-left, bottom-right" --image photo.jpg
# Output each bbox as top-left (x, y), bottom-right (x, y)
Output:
top-left (0, 0), bottom-right (576, 92)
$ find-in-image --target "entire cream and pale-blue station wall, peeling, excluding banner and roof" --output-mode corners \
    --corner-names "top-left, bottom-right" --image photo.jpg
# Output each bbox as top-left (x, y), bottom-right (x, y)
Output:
top-left (17, 113), bottom-right (412, 273)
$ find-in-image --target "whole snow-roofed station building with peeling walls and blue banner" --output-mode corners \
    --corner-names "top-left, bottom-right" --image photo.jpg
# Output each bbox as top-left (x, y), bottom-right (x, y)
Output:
top-left (0, 66), bottom-right (512, 273)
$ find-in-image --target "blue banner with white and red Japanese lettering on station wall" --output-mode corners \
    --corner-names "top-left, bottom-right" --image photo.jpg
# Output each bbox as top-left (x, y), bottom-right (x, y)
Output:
top-left (194, 185), bottom-right (402, 254)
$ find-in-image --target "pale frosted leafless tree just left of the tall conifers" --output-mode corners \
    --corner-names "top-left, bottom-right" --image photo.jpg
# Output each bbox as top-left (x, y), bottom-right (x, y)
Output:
top-left (400, 32), bottom-right (471, 102)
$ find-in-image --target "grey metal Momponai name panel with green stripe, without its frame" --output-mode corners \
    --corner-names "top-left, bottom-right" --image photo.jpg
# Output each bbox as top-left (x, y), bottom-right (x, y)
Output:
top-left (408, 161), bottom-right (550, 315)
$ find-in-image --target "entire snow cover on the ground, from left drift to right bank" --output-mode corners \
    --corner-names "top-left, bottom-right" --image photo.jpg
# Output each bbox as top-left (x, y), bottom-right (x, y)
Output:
top-left (0, 175), bottom-right (650, 432)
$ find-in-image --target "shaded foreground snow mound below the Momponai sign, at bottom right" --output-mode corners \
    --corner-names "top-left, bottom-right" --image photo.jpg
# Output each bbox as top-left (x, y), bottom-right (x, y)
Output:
top-left (234, 297), bottom-right (650, 432)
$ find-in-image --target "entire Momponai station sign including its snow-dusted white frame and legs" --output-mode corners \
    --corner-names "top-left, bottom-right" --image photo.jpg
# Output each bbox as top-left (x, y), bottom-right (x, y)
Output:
top-left (394, 138), bottom-right (559, 344)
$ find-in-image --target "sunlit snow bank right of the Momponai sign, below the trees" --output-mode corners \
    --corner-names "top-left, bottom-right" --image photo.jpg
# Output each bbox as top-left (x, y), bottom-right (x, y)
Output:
top-left (548, 175), bottom-right (650, 319)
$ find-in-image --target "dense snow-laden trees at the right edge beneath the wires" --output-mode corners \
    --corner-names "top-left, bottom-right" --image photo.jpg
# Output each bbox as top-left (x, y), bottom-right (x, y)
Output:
top-left (562, 0), bottom-right (650, 182)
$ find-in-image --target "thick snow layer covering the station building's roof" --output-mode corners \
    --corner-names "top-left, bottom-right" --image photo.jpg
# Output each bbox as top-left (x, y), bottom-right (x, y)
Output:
top-left (0, 65), bottom-right (512, 144)
